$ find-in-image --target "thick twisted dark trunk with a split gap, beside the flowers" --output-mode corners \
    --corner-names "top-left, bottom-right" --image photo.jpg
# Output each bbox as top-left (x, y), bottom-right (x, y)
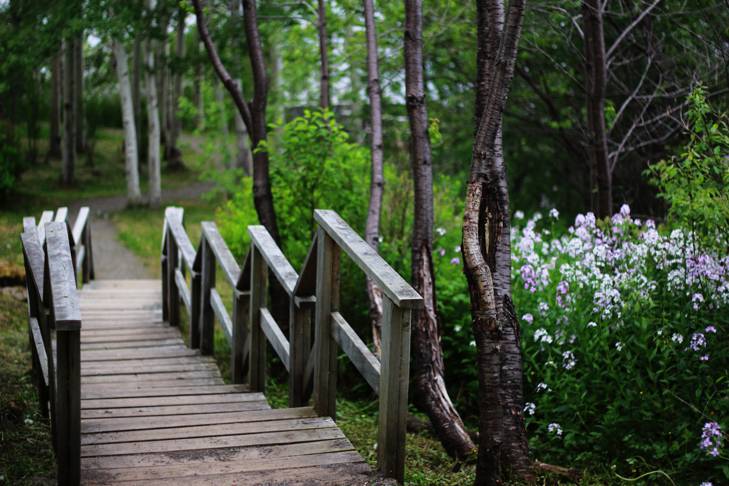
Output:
top-left (462, 0), bottom-right (532, 485)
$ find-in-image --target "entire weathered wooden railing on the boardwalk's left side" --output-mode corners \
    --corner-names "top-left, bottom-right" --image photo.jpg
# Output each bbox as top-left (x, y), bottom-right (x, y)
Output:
top-left (21, 208), bottom-right (94, 485)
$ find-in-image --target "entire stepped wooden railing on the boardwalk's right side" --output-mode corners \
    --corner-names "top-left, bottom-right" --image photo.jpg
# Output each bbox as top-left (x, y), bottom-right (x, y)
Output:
top-left (162, 208), bottom-right (422, 481)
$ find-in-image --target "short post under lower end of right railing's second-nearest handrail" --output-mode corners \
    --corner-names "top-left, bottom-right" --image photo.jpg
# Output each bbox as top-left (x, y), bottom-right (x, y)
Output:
top-left (289, 296), bottom-right (314, 407)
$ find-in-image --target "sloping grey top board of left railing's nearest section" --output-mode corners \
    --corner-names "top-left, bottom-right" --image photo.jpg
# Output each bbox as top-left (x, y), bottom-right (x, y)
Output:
top-left (46, 222), bottom-right (81, 331)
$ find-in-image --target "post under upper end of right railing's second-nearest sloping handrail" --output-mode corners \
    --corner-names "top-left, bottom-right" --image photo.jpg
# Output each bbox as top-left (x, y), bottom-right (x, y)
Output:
top-left (248, 245), bottom-right (268, 392)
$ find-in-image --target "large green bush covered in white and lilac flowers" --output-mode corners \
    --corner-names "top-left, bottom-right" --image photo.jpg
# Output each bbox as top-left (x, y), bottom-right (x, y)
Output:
top-left (512, 206), bottom-right (729, 483)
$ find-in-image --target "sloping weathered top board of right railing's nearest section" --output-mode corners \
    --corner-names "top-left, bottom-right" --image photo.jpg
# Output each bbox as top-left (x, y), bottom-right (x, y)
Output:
top-left (314, 209), bottom-right (423, 309)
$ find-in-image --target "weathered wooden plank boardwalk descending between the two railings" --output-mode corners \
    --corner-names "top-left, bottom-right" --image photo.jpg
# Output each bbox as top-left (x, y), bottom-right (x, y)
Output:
top-left (79, 280), bottom-right (377, 485)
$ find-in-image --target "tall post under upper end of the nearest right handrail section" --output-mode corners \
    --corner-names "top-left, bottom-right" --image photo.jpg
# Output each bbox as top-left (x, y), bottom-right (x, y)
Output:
top-left (314, 227), bottom-right (339, 419)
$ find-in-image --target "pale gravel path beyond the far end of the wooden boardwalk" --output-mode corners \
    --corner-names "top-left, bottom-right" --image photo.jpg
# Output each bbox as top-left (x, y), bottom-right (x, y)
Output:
top-left (69, 183), bottom-right (211, 279)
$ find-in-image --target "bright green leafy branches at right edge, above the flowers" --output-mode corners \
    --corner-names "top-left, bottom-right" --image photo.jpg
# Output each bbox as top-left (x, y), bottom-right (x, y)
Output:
top-left (646, 87), bottom-right (729, 246)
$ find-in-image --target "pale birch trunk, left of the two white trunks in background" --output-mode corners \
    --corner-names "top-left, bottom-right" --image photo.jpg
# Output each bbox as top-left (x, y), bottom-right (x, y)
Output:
top-left (112, 41), bottom-right (142, 205)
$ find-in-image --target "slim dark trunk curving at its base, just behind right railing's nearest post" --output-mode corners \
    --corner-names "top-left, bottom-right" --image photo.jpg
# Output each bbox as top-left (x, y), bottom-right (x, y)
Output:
top-left (405, 0), bottom-right (474, 457)
